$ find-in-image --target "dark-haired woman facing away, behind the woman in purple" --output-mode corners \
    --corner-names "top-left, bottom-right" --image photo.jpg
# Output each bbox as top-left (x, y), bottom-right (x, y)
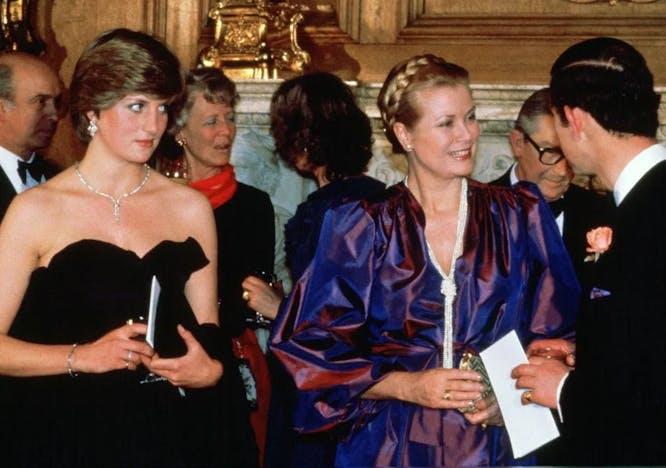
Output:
top-left (243, 73), bottom-right (384, 467)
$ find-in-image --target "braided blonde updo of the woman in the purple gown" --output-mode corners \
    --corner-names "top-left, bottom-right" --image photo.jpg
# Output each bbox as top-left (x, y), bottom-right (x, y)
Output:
top-left (377, 54), bottom-right (469, 153)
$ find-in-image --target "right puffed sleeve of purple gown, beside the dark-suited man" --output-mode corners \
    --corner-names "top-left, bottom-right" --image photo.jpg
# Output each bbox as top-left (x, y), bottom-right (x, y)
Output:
top-left (516, 184), bottom-right (580, 342)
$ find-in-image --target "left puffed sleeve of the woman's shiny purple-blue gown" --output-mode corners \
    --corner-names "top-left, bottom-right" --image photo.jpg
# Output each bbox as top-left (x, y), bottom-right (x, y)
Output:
top-left (271, 203), bottom-right (387, 432)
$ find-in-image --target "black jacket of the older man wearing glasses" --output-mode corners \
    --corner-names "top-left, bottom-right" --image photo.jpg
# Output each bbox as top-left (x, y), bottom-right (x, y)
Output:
top-left (490, 170), bottom-right (613, 289)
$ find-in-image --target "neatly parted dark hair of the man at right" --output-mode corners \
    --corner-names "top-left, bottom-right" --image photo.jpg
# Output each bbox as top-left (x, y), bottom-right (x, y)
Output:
top-left (550, 37), bottom-right (660, 138)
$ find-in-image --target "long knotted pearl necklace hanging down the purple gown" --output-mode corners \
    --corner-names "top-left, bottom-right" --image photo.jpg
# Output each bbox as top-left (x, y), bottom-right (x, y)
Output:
top-left (405, 177), bottom-right (467, 369)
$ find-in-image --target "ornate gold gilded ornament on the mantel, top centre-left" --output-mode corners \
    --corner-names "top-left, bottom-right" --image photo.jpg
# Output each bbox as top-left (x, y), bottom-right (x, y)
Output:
top-left (197, 0), bottom-right (310, 79)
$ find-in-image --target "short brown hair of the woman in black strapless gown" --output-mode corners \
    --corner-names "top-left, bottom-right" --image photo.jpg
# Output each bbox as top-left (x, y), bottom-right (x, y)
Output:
top-left (70, 28), bottom-right (183, 142)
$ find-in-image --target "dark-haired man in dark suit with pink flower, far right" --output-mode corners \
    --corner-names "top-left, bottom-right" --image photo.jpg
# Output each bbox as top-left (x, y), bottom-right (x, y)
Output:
top-left (513, 38), bottom-right (666, 465)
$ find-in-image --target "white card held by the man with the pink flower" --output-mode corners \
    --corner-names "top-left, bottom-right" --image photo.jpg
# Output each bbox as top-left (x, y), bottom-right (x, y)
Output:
top-left (479, 330), bottom-right (560, 458)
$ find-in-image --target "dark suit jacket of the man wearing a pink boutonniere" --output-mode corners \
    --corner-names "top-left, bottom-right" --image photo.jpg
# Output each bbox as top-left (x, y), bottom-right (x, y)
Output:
top-left (560, 162), bottom-right (666, 465)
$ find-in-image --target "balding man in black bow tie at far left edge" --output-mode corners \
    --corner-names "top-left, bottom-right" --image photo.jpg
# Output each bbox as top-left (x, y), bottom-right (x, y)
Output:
top-left (0, 52), bottom-right (62, 220)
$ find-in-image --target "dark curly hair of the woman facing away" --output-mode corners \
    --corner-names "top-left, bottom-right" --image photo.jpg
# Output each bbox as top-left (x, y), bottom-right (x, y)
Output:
top-left (271, 72), bottom-right (372, 181)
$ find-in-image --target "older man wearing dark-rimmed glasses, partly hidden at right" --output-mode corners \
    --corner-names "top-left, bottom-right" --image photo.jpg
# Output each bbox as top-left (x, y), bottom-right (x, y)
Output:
top-left (491, 88), bottom-right (612, 282)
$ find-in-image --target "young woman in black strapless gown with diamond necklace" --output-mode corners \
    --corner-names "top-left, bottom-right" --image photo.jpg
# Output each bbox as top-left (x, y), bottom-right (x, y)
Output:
top-left (0, 29), bottom-right (252, 467)
